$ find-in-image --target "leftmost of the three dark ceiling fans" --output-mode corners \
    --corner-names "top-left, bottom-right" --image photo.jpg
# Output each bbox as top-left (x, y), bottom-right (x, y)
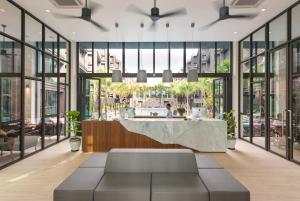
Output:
top-left (53, 0), bottom-right (109, 32)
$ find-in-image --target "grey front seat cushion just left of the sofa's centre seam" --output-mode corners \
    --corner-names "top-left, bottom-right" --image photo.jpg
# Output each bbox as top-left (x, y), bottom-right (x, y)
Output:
top-left (94, 173), bottom-right (151, 201)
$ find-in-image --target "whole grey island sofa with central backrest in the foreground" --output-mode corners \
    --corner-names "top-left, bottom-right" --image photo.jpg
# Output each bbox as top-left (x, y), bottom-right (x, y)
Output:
top-left (54, 149), bottom-right (250, 201)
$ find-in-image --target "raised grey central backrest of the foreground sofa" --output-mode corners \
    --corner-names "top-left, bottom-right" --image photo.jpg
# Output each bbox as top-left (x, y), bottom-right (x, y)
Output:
top-left (105, 149), bottom-right (198, 173)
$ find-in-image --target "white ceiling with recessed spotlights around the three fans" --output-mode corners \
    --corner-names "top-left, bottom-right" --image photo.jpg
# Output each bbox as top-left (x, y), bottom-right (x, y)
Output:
top-left (4, 0), bottom-right (297, 41)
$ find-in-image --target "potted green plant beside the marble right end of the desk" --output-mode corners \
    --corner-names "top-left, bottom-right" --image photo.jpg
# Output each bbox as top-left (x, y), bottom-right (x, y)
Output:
top-left (224, 110), bottom-right (236, 150)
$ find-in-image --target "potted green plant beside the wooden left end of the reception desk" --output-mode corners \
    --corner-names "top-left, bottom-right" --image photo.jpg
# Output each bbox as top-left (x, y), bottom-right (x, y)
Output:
top-left (65, 111), bottom-right (81, 152)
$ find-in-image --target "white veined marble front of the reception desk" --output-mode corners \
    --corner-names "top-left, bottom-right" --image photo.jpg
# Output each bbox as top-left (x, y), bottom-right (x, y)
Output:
top-left (120, 119), bottom-right (227, 152)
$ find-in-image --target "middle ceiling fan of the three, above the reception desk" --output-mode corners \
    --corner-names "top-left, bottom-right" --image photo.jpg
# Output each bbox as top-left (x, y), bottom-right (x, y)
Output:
top-left (127, 0), bottom-right (187, 29)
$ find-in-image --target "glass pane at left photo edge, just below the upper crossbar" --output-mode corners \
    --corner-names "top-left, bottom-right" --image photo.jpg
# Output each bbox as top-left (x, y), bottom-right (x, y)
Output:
top-left (0, 35), bottom-right (21, 73)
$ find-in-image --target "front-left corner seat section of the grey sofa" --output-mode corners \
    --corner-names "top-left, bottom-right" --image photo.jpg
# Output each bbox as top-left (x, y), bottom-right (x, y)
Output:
top-left (53, 168), bottom-right (104, 201)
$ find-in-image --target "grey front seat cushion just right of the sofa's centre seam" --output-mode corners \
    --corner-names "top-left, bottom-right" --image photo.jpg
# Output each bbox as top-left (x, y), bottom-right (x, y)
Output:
top-left (152, 173), bottom-right (209, 201)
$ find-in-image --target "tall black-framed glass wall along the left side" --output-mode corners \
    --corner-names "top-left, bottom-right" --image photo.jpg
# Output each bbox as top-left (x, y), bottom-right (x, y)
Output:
top-left (0, 0), bottom-right (70, 168)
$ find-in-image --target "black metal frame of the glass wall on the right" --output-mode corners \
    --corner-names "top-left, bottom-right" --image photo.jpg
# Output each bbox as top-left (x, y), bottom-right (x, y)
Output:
top-left (238, 1), bottom-right (300, 164)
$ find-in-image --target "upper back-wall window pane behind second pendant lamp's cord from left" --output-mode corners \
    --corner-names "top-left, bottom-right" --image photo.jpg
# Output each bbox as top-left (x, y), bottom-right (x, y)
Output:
top-left (140, 42), bottom-right (154, 73)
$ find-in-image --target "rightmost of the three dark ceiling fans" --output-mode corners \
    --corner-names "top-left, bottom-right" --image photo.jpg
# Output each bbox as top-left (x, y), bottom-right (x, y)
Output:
top-left (200, 0), bottom-right (257, 31)
